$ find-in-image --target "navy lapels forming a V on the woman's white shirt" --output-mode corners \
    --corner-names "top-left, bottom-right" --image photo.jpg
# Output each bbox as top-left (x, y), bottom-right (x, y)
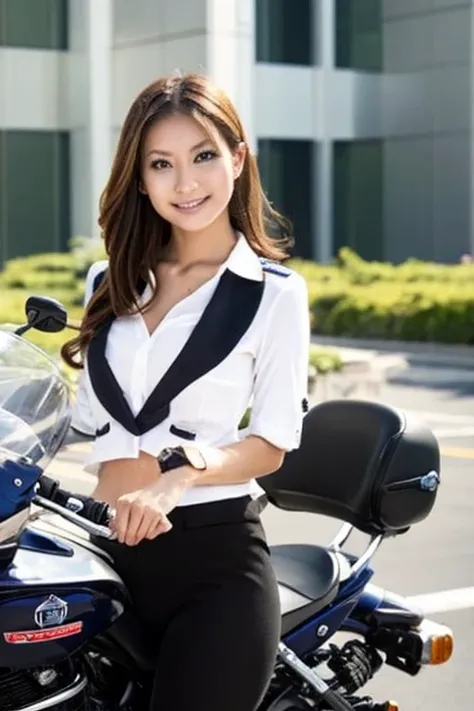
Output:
top-left (87, 270), bottom-right (265, 436)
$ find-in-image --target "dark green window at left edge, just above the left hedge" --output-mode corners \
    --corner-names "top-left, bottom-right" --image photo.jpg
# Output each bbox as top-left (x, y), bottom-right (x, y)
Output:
top-left (0, 131), bottom-right (70, 262)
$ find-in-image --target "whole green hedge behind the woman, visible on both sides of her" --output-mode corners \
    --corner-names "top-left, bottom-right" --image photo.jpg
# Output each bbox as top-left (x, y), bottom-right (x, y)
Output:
top-left (0, 246), bottom-right (474, 354)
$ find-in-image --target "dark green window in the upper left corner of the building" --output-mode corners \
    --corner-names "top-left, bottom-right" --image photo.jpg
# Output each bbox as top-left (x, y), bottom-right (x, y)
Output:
top-left (0, 0), bottom-right (68, 50)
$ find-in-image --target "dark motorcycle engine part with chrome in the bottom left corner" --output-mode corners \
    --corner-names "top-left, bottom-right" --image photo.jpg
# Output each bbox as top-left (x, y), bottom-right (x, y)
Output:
top-left (0, 660), bottom-right (87, 711)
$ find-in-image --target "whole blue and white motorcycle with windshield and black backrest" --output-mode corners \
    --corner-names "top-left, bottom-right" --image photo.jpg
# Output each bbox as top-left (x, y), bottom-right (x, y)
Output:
top-left (0, 297), bottom-right (453, 711)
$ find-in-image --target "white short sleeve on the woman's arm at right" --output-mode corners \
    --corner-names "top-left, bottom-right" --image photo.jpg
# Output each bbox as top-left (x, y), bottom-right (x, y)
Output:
top-left (248, 273), bottom-right (310, 451)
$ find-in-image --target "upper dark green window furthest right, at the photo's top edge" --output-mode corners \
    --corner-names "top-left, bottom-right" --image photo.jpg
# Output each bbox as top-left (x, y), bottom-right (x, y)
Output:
top-left (336, 0), bottom-right (383, 72)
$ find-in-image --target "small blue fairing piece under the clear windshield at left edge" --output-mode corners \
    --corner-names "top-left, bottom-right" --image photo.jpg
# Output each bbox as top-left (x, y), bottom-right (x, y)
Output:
top-left (0, 460), bottom-right (43, 522)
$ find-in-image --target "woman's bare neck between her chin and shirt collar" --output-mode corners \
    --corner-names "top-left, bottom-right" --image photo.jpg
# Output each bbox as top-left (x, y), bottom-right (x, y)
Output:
top-left (167, 215), bottom-right (236, 268)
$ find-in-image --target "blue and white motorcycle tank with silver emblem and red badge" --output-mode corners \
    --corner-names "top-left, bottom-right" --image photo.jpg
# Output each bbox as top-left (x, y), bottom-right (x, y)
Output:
top-left (0, 531), bottom-right (128, 669)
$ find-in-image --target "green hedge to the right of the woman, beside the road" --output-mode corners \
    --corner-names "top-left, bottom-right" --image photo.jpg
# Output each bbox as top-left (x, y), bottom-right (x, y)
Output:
top-left (290, 248), bottom-right (474, 344)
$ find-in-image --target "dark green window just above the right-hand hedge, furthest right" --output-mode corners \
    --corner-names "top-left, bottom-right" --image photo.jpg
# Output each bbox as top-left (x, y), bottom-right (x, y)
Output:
top-left (333, 141), bottom-right (384, 260)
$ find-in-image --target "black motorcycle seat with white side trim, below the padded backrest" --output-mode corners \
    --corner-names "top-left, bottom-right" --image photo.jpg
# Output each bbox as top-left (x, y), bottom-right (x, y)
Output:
top-left (270, 544), bottom-right (350, 635)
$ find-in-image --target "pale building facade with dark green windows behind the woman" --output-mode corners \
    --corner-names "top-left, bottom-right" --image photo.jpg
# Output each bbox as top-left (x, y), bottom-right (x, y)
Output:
top-left (0, 0), bottom-right (474, 262)
